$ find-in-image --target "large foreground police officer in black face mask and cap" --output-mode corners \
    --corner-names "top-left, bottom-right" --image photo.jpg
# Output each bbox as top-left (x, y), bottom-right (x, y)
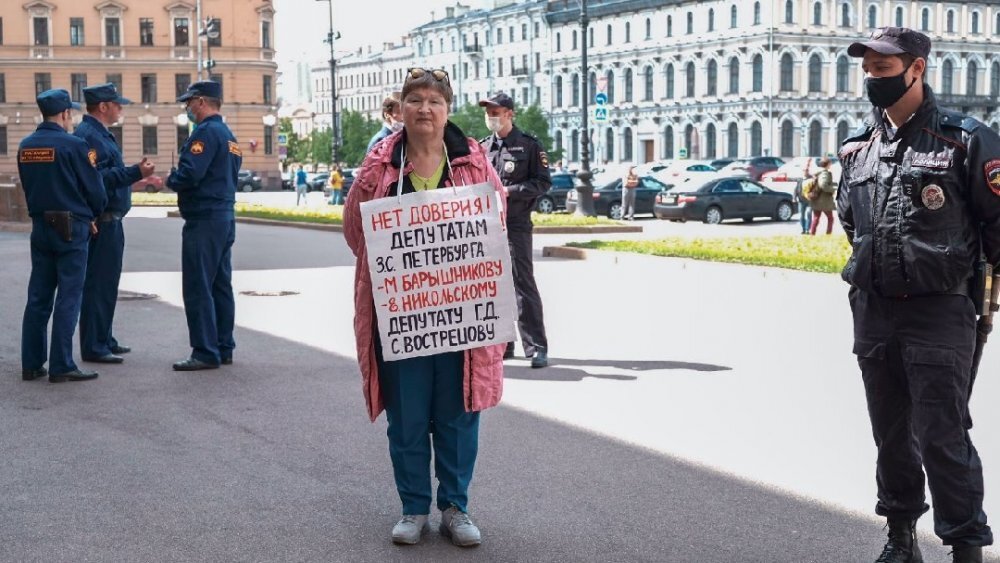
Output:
top-left (837, 27), bottom-right (1000, 563)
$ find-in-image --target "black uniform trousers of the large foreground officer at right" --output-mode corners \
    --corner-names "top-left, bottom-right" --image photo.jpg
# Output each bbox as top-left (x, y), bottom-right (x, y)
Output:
top-left (849, 288), bottom-right (993, 545)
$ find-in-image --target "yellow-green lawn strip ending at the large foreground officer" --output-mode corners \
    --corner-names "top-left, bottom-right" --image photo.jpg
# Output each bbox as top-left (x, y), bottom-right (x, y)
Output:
top-left (569, 235), bottom-right (851, 273)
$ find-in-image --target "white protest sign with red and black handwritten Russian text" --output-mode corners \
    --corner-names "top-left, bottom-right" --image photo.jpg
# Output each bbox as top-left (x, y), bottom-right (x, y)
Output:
top-left (361, 183), bottom-right (517, 360)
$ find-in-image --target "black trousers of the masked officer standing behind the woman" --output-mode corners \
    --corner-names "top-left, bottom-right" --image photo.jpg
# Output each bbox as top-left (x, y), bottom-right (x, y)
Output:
top-left (507, 229), bottom-right (549, 356)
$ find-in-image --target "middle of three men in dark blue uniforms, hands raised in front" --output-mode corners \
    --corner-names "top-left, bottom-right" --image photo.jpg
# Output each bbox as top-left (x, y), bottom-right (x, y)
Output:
top-left (73, 82), bottom-right (154, 364)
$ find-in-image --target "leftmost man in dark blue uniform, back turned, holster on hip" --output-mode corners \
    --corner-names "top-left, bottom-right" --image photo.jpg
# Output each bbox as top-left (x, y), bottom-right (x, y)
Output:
top-left (17, 90), bottom-right (108, 383)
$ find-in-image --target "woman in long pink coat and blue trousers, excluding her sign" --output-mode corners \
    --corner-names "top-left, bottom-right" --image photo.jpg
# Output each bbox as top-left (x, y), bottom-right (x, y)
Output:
top-left (344, 68), bottom-right (513, 546)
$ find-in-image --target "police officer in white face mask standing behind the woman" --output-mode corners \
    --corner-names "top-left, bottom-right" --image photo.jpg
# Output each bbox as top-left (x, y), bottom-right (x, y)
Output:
top-left (479, 92), bottom-right (552, 368)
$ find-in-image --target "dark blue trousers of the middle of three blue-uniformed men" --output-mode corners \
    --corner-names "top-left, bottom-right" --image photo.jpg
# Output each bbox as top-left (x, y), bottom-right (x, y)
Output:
top-left (80, 219), bottom-right (125, 360)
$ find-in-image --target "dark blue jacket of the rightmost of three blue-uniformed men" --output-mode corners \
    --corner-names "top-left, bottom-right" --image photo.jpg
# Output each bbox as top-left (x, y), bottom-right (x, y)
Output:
top-left (167, 115), bottom-right (243, 219)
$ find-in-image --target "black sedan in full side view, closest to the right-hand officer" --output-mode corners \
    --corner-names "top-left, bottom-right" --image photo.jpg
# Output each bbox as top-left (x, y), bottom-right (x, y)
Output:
top-left (653, 178), bottom-right (793, 225)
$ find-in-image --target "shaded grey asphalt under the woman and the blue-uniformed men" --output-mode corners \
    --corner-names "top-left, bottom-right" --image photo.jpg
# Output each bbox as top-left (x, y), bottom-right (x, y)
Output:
top-left (0, 226), bottom-right (988, 563)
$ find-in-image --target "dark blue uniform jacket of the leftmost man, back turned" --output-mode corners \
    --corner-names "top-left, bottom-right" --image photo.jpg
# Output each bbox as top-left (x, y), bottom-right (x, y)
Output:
top-left (17, 121), bottom-right (108, 221)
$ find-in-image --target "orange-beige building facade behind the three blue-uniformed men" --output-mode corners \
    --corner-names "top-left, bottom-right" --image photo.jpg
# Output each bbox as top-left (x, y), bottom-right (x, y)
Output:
top-left (0, 0), bottom-right (280, 186)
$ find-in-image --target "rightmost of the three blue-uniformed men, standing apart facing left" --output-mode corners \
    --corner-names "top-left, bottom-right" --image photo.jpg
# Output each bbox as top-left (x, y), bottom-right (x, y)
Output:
top-left (167, 80), bottom-right (243, 371)
